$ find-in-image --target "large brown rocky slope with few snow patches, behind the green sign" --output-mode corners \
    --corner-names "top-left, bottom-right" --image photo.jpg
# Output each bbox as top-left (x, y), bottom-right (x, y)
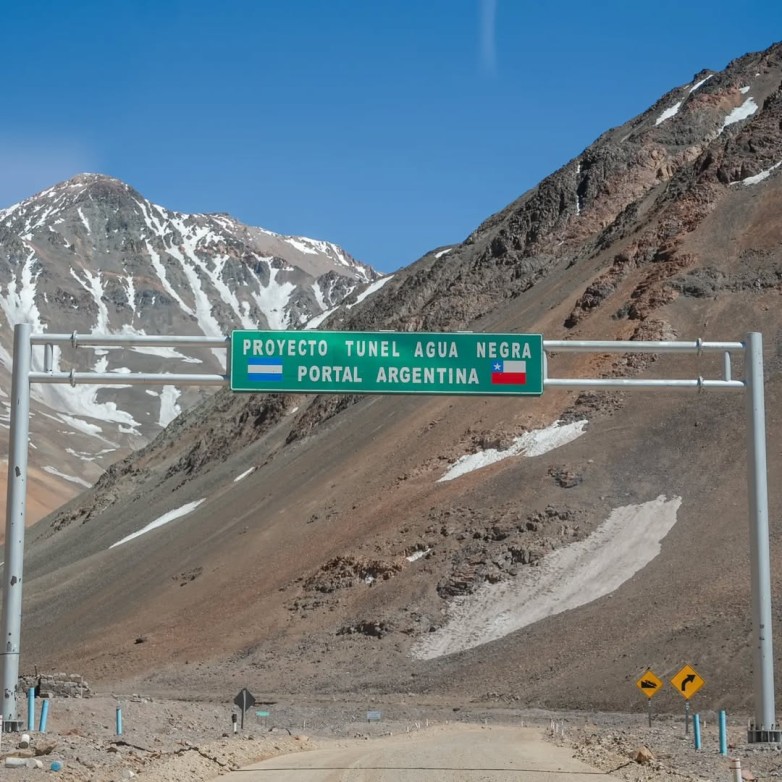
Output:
top-left (9, 45), bottom-right (782, 711)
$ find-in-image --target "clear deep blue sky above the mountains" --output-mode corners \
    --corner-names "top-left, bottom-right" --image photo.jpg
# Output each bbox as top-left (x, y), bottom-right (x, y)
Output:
top-left (0, 0), bottom-right (782, 271)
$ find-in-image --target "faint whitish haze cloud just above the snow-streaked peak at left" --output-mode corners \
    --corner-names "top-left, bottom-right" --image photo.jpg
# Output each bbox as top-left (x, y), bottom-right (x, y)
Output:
top-left (0, 135), bottom-right (99, 209)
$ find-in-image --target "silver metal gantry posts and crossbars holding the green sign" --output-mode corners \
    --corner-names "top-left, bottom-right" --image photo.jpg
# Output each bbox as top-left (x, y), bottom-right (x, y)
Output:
top-left (0, 324), bottom-right (782, 742)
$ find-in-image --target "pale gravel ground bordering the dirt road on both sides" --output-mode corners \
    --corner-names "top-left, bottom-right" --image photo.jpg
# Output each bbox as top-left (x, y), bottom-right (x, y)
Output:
top-left (0, 695), bottom-right (782, 782)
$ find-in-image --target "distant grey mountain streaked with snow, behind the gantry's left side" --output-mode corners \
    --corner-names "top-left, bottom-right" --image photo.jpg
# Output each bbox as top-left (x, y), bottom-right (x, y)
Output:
top-left (0, 174), bottom-right (379, 512)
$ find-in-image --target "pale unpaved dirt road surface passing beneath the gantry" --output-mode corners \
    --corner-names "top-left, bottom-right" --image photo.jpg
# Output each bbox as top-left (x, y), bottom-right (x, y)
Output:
top-left (220, 725), bottom-right (613, 782)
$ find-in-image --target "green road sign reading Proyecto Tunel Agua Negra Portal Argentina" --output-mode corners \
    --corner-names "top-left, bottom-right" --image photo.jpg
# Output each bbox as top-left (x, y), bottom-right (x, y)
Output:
top-left (231, 331), bottom-right (543, 395)
